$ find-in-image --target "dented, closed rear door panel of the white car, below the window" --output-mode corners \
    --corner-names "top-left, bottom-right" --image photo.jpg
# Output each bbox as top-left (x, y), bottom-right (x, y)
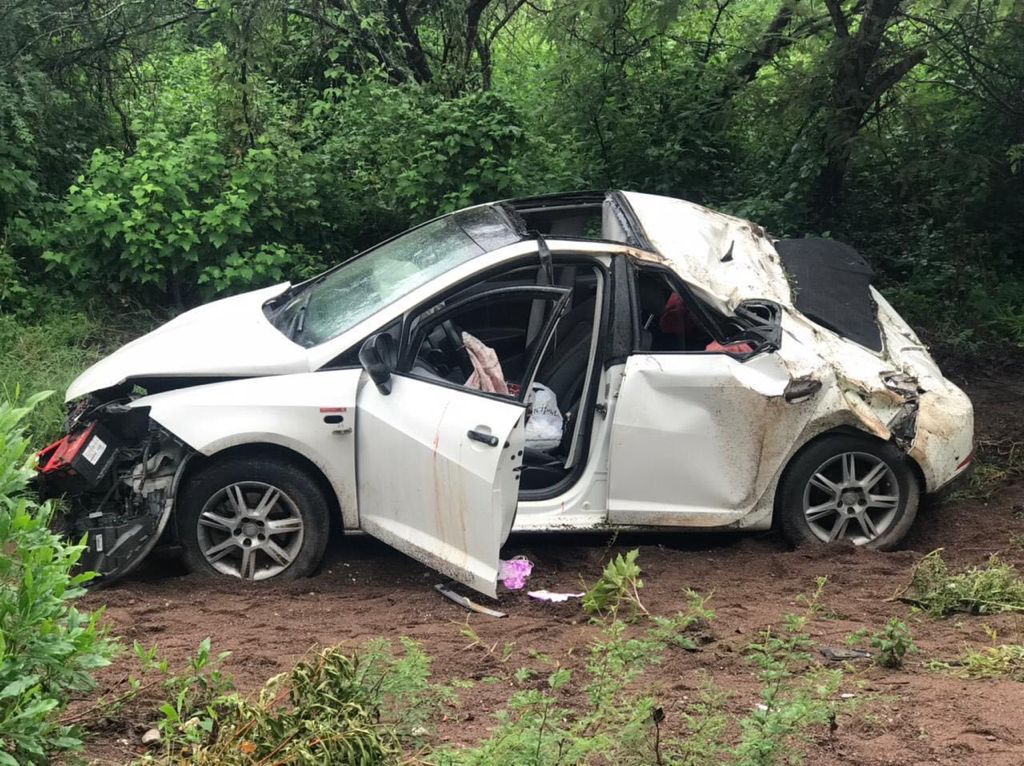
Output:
top-left (608, 353), bottom-right (806, 526)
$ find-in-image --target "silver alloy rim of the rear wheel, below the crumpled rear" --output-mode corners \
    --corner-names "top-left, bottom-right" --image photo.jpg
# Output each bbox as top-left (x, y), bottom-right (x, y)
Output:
top-left (803, 452), bottom-right (900, 545)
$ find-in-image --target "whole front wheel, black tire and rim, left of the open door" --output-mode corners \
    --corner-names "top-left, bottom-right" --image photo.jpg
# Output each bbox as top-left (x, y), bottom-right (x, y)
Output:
top-left (177, 458), bottom-right (330, 581)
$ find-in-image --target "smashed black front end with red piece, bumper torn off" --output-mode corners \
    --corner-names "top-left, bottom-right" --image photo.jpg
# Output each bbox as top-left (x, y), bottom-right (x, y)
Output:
top-left (37, 405), bottom-right (190, 585)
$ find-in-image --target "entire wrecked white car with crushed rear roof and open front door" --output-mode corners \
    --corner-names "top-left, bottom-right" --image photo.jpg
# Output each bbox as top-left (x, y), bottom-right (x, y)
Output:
top-left (39, 192), bottom-right (973, 596)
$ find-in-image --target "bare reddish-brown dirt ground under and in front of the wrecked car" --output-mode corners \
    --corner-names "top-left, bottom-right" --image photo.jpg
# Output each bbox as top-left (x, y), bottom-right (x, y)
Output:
top-left (73, 374), bottom-right (1024, 766)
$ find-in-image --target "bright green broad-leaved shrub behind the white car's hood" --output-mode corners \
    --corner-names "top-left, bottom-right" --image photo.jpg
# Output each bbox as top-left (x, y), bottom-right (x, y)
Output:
top-left (43, 115), bottom-right (316, 305)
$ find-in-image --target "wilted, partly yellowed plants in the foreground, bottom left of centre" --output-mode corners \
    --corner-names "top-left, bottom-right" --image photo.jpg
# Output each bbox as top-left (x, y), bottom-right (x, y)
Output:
top-left (146, 638), bottom-right (451, 766)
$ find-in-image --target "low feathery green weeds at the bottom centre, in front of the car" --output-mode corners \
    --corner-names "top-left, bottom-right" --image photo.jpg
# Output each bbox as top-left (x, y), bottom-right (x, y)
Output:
top-left (429, 581), bottom-right (726, 766)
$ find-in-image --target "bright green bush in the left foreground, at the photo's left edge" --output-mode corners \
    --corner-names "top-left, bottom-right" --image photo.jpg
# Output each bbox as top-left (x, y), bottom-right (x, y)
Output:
top-left (0, 395), bottom-right (114, 766)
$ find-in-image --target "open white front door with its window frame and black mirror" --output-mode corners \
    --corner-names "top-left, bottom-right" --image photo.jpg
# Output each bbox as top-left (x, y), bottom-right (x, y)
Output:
top-left (355, 287), bottom-right (569, 597)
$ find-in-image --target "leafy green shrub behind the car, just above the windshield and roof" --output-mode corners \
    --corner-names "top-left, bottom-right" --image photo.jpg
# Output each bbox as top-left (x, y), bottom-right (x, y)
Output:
top-left (307, 75), bottom-right (553, 223)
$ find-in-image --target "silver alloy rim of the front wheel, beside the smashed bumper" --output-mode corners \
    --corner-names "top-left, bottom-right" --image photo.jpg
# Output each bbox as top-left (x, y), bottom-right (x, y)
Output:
top-left (196, 481), bottom-right (304, 580)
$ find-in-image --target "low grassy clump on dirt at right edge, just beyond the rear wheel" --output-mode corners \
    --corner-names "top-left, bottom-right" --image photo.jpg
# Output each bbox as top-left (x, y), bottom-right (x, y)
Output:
top-left (901, 549), bottom-right (1024, 618)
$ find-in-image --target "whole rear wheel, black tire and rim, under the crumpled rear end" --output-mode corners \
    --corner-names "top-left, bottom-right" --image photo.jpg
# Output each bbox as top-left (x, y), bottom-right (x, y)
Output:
top-left (775, 434), bottom-right (921, 551)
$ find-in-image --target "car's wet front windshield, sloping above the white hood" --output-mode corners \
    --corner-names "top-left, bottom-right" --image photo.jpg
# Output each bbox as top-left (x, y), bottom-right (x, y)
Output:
top-left (274, 207), bottom-right (518, 348)
